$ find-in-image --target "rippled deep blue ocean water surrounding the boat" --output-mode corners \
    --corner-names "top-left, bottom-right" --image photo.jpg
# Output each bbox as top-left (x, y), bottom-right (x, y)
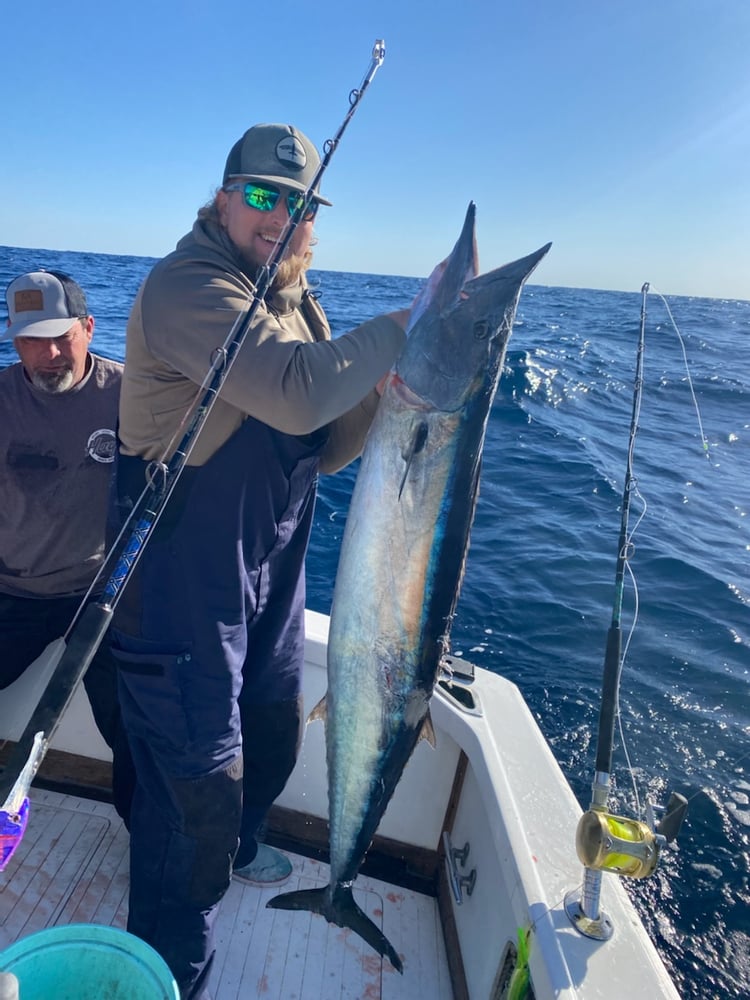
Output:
top-left (0, 247), bottom-right (750, 1000)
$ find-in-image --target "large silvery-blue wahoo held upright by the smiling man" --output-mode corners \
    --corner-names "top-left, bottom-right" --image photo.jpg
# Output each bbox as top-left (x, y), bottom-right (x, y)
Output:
top-left (267, 204), bottom-right (549, 972)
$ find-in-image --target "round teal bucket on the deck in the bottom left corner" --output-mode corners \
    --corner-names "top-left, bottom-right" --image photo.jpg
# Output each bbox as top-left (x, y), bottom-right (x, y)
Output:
top-left (0, 924), bottom-right (180, 1000)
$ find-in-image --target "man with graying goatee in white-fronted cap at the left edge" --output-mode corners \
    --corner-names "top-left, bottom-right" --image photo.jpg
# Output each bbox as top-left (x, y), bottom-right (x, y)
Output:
top-left (0, 270), bottom-right (127, 772)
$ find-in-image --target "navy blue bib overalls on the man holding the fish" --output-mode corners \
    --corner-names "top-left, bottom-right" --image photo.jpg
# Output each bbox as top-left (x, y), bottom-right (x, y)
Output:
top-left (112, 410), bottom-right (327, 1000)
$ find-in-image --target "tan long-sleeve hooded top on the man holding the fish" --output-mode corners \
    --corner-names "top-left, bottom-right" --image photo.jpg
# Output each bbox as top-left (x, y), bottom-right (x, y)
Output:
top-left (120, 221), bottom-right (404, 472)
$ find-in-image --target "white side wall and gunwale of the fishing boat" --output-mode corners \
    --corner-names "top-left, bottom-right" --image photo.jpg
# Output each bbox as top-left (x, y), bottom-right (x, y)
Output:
top-left (0, 612), bottom-right (679, 1000)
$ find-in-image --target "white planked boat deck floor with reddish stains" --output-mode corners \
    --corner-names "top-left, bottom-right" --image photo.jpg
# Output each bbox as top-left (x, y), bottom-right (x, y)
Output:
top-left (0, 790), bottom-right (453, 1000)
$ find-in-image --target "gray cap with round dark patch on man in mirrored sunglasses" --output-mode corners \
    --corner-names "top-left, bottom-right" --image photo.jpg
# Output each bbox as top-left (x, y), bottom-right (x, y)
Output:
top-left (223, 125), bottom-right (331, 205)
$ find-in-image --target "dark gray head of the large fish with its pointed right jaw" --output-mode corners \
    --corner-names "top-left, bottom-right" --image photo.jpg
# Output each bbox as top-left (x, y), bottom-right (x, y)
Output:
top-left (395, 234), bottom-right (551, 411)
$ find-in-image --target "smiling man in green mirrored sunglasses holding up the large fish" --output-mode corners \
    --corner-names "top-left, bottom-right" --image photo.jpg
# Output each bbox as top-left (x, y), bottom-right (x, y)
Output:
top-left (108, 125), bottom-right (408, 1000)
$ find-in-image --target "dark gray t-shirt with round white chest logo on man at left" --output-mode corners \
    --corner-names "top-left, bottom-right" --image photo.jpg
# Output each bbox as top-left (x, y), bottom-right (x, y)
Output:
top-left (0, 354), bottom-right (122, 597)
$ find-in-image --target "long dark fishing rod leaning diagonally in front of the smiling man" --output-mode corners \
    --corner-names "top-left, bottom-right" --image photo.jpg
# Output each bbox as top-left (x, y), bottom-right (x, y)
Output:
top-left (0, 39), bottom-right (385, 871)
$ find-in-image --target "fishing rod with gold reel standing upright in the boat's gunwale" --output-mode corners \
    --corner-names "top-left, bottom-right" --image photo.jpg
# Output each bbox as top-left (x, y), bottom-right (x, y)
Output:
top-left (565, 282), bottom-right (687, 941)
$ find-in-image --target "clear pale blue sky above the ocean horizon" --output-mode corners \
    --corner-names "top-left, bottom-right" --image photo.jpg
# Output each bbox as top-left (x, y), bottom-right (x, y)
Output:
top-left (0, 0), bottom-right (750, 299)
